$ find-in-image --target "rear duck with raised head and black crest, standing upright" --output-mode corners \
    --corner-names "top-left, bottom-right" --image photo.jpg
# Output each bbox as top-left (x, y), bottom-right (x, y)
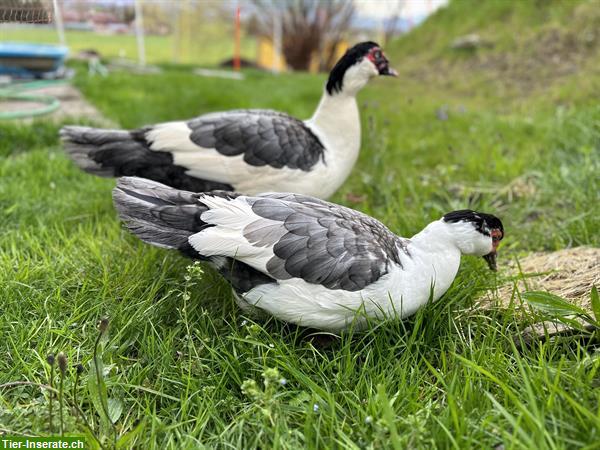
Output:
top-left (60, 42), bottom-right (397, 198)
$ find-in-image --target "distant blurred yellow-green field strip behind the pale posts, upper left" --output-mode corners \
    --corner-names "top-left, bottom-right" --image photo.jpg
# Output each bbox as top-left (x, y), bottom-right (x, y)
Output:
top-left (0, 22), bottom-right (256, 66)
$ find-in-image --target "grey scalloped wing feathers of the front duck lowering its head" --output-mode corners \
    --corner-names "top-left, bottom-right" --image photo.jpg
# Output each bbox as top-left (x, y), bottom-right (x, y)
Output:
top-left (245, 193), bottom-right (404, 291)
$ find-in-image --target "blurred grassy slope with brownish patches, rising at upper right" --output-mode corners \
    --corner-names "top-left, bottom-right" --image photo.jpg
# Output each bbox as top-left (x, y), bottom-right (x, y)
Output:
top-left (386, 0), bottom-right (600, 112)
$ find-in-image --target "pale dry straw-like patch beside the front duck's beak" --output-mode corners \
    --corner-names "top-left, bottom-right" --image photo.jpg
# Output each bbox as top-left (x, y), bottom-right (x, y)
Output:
top-left (481, 247), bottom-right (600, 313)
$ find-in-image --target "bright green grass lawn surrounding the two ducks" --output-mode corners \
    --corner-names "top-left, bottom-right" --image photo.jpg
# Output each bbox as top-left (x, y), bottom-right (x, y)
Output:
top-left (0, 3), bottom-right (600, 449)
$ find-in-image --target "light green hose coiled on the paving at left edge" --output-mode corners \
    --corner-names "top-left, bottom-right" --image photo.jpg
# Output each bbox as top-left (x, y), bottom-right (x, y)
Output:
top-left (0, 80), bottom-right (67, 120)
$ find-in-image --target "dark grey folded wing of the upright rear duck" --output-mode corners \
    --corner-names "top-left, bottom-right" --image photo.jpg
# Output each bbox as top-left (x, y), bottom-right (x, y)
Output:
top-left (187, 109), bottom-right (325, 171)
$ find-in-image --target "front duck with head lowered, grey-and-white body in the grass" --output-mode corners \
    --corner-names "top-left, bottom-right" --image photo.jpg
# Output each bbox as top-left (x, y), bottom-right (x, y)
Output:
top-left (113, 177), bottom-right (504, 332)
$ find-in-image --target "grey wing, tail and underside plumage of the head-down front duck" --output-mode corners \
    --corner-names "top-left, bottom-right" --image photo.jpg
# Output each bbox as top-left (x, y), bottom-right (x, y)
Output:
top-left (114, 178), bottom-right (405, 293)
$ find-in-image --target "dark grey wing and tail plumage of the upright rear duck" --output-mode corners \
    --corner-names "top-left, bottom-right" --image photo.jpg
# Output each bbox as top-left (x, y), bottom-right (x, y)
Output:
top-left (60, 110), bottom-right (325, 192)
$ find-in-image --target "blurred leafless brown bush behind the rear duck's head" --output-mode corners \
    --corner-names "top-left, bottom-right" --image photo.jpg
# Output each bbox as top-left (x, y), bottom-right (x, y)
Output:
top-left (252, 0), bottom-right (354, 70)
